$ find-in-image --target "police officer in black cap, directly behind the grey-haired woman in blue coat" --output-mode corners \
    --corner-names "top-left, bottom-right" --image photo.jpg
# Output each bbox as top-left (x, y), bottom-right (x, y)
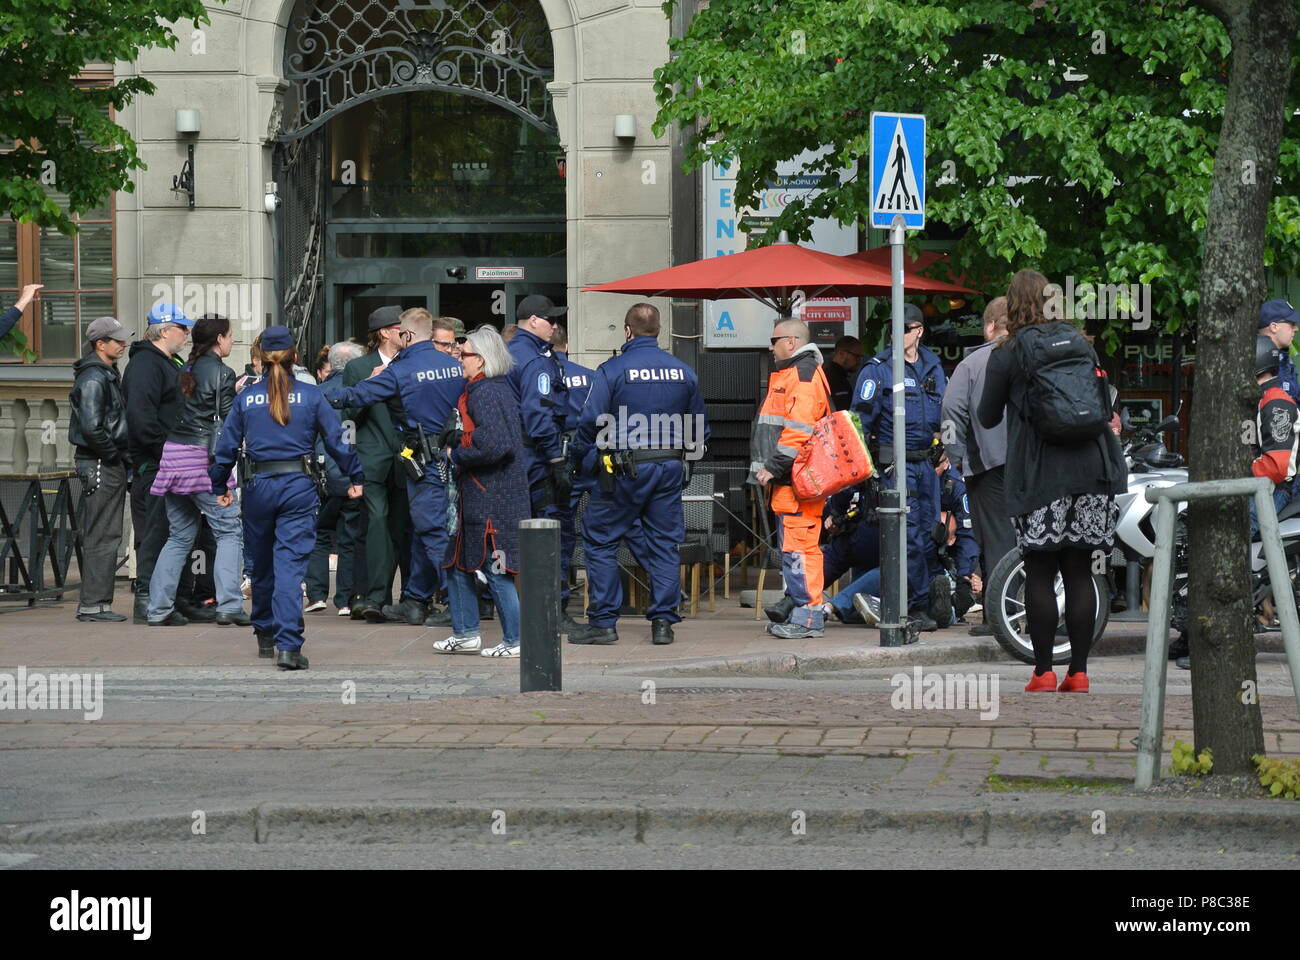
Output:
top-left (507, 294), bottom-right (573, 518)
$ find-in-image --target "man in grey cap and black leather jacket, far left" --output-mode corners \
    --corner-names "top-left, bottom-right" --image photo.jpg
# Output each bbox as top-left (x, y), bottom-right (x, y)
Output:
top-left (68, 316), bottom-right (131, 622)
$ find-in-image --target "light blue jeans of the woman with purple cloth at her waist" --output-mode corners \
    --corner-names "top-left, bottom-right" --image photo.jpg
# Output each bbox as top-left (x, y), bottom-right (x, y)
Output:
top-left (148, 493), bottom-right (243, 622)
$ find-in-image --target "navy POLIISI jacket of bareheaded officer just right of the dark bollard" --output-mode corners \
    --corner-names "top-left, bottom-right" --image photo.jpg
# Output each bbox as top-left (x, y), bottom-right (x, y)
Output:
top-left (575, 337), bottom-right (709, 473)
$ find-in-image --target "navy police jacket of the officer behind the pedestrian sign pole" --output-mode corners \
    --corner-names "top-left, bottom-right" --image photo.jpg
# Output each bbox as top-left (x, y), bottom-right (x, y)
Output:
top-left (853, 346), bottom-right (948, 450)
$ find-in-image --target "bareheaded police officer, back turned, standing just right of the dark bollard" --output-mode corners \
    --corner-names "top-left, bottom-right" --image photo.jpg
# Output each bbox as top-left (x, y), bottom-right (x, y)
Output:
top-left (568, 303), bottom-right (709, 644)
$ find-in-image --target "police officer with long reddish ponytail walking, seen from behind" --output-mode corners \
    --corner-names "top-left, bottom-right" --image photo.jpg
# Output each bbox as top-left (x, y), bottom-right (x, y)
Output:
top-left (208, 327), bottom-right (365, 670)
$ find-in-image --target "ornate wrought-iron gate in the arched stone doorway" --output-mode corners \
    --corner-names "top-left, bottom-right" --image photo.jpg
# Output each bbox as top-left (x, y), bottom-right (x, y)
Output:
top-left (274, 0), bottom-right (556, 351)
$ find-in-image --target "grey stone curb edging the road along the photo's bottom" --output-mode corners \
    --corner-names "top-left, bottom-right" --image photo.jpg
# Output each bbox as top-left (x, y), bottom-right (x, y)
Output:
top-left (0, 796), bottom-right (1300, 855)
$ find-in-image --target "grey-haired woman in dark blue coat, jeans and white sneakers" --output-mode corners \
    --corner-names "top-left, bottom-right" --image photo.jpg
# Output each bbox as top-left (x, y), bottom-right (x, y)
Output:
top-left (433, 327), bottom-right (532, 657)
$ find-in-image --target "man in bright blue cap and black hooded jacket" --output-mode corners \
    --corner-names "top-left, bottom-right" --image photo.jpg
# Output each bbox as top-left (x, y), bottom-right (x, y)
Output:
top-left (122, 303), bottom-right (194, 623)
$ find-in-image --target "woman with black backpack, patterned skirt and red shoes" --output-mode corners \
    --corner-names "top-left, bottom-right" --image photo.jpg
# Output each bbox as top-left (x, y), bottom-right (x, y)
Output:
top-left (979, 271), bottom-right (1128, 693)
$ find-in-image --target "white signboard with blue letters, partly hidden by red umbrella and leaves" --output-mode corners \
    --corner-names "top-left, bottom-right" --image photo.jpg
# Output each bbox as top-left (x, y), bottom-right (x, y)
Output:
top-left (701, 151), bottom-right (858, 347)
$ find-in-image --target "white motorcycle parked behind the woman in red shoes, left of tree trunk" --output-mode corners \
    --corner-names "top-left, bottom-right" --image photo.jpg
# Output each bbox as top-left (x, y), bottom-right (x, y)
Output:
top-left (984, 414), bottom-right (1190, 663)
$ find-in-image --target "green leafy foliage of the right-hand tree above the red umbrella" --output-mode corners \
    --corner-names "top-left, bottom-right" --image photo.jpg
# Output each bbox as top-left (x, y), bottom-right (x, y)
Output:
top-left (655, 0), bottom-right (1300, 345)
